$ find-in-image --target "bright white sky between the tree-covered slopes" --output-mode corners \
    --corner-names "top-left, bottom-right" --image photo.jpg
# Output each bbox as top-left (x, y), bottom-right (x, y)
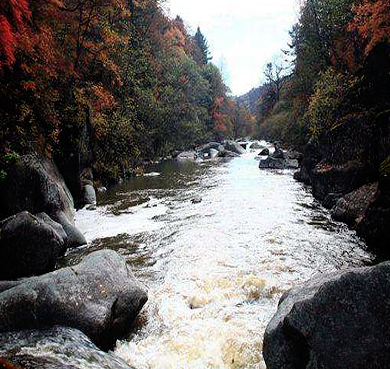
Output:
top-left (167, 0), bottom-right (298, 95)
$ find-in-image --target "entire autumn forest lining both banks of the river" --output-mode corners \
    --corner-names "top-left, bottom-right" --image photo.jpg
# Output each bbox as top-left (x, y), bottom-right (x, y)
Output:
top-left (0, 0), bottom-right (390, 182)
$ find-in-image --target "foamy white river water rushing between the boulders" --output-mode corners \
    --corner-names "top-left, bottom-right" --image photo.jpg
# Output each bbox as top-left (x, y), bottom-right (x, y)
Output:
top-left (72, 142), bottom-right (372, 369)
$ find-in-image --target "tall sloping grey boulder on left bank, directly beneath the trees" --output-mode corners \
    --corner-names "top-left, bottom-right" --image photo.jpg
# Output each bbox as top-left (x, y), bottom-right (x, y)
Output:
top-left (0, 154), bottom-right (86, 247)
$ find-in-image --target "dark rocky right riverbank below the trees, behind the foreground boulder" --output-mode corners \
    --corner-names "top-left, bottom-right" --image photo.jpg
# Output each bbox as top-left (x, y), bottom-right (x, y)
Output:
top-left (295, 140), bottom-right (390, 258)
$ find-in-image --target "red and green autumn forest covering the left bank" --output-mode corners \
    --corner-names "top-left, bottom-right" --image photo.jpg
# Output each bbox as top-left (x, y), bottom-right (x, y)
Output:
top-left (0, 0), bottom-right (254, 182)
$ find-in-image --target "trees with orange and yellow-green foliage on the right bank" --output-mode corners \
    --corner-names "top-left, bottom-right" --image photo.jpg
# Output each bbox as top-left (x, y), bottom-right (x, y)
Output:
top-left (257, 0), bottom-right (390, 172)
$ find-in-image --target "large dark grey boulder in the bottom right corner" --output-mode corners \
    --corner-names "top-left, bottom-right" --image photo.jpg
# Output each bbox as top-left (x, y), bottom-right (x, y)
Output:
top-left (263, 262), bottom-right (390, 369)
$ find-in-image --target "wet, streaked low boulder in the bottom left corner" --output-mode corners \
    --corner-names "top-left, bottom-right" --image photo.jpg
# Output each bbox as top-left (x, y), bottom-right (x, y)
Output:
top-left (0, 326), bottom-right (131, 369)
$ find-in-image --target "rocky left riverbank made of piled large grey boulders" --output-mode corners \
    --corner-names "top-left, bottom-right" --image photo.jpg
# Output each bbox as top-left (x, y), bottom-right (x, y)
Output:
top-left (0, 154), bottom-right (148, 368)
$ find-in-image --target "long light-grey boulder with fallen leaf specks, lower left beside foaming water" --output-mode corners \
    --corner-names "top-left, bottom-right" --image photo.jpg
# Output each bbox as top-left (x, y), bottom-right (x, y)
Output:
top-left (0, 250), bottom-right (147, 349)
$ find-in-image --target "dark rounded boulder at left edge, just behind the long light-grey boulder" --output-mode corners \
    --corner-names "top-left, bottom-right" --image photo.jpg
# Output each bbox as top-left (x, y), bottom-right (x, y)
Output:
top-left (0, 211), bottom-right (65, 280)
